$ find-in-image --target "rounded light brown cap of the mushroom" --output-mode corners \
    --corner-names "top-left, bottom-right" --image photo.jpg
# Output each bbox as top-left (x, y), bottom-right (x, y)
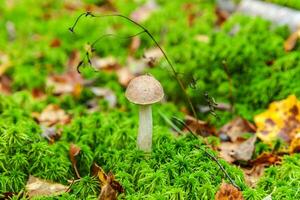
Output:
top-left (125, 75), bottom-right (164, 105)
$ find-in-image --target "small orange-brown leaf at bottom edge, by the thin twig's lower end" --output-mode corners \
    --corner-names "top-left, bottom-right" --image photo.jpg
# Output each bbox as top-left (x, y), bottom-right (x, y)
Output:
top-left (215, 182), bottom-right (244, 200)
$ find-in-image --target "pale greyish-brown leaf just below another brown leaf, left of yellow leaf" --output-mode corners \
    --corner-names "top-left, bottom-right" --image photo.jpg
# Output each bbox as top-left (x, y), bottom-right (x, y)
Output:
top-left (220, 136), bottom-right (257, 163)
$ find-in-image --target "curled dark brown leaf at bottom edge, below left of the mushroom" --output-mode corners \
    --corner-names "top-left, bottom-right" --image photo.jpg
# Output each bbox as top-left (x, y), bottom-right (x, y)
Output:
top-left (92, 163), bottom-right (124, 200)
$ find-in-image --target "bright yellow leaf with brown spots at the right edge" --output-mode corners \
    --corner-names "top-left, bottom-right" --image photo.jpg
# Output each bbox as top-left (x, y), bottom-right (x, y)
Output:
top-left (254, 95), bottom-right (300, 143)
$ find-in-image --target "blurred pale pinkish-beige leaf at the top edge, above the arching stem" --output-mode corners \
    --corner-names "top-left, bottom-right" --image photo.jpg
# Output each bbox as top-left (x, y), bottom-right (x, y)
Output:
top-left (130, 0), bottom-right (158, 22)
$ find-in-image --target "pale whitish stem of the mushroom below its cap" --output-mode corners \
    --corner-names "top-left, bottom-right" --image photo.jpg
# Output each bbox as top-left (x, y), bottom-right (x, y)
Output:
top-left (137, 105), bottom-right (152, 152)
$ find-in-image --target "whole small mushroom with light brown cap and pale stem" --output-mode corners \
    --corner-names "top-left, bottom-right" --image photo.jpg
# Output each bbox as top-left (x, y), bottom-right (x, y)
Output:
top-left (125, 75), bottom-right (164, 152)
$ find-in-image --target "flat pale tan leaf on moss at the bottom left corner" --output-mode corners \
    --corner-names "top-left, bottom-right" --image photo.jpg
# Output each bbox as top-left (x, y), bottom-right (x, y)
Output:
top-left (26, 175), bottom-right (69, 198)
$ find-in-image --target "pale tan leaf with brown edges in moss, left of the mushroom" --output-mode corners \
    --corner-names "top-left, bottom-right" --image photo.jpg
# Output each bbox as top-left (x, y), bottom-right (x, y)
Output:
top-left (33, 104), bottom-right (71, 127)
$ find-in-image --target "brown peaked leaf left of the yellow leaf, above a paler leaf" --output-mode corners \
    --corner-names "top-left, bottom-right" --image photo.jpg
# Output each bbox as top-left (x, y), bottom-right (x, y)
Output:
top-left (218, 117), bottom-right (256, 142)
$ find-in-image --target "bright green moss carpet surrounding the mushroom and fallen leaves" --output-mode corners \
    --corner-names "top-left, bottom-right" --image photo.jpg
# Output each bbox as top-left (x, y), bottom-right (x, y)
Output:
top-left (0, 0), bottom-right (300, 200)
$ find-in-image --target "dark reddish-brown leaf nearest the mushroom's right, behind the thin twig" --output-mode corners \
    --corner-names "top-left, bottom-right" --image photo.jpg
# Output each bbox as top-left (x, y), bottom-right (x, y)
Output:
top-left (184, 115), bottom-right (217, 136)
